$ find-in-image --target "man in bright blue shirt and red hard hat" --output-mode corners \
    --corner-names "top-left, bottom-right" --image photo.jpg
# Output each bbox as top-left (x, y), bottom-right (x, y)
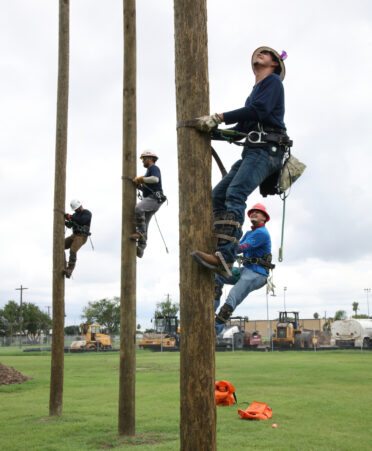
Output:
top-left (214, 204), bottom-right (275, 335)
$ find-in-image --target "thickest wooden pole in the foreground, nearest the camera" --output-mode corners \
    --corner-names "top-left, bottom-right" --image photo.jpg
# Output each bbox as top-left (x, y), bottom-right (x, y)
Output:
top-left (174, 0), bottom-right (216, 451)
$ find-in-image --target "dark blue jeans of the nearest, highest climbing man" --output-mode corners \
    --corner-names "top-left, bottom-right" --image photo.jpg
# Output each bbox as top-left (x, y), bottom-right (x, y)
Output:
top-left (212, 147), bottom-right (283, 263)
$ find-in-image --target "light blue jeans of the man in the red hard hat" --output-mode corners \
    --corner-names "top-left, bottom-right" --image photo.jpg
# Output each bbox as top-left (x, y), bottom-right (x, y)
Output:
top-left (214, 267), bottom-right (267, 335)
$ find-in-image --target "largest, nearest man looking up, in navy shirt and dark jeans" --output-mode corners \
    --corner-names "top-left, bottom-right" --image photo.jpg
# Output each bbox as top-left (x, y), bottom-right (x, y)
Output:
top-left (191, 47), bottom-right (290, 277)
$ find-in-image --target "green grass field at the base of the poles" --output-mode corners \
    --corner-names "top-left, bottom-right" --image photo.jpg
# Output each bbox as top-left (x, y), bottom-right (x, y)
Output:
top-left (0, 349), bottom-right (372, 451)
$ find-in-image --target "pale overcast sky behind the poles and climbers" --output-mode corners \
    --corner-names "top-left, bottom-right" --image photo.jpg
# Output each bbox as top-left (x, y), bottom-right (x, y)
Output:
top-left (0, 0), bottom-right (372, 326)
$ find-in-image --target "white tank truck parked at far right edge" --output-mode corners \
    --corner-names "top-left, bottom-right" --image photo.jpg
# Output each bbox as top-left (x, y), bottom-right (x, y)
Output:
top-left (331, 319), bottom-right (372, 348)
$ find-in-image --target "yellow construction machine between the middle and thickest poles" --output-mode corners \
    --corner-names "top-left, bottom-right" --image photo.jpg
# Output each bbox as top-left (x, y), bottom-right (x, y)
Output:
top-left (138, 316), bottom-right (180, 351)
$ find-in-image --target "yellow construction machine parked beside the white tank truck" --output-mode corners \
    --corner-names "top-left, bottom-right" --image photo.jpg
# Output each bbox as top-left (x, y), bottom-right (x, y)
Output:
top-left (272, 312), bottom-right (317, 349)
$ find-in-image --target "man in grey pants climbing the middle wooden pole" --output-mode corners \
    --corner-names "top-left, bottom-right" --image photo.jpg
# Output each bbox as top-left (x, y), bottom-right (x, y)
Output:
top-left (130, 150), bottom-right (167, 258)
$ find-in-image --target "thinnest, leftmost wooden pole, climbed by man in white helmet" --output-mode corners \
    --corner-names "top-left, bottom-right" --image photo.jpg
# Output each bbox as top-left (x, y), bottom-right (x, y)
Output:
top-left (49, 0), bottom-right (70, 416)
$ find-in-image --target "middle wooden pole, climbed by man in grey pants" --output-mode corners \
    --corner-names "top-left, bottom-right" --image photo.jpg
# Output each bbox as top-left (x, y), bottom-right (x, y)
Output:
top-left (119, 0), bottom-right (137, 436)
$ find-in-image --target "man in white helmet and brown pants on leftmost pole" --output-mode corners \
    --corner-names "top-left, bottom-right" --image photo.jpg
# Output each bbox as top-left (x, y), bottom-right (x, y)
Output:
top-left (63, 199), bottom-right (92, 279)
